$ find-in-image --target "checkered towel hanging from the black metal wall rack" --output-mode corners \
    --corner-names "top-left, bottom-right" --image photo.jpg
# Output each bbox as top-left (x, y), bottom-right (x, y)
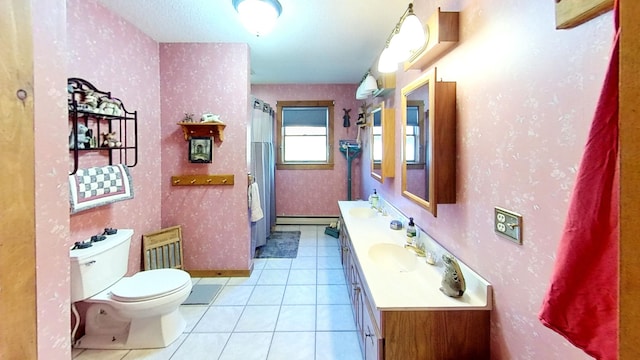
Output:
top-left (69, 164), bottom-right (133, 214)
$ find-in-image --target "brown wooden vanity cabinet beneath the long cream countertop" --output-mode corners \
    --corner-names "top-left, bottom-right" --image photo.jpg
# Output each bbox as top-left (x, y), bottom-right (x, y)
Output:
top-left (340, 218), bottom-right (490, 360)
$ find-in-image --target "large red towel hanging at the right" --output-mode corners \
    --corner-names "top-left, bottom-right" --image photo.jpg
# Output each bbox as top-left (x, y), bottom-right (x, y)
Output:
top-left (539, 1), bottom-right (620, 360)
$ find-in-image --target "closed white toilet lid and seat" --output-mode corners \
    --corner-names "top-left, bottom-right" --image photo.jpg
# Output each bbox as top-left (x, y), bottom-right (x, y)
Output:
top-left (111, 269), bottom-right (191, 302)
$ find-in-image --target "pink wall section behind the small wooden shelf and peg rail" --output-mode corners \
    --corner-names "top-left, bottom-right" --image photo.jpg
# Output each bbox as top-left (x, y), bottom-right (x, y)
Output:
top-left (156, 44), bottom-right (251, 270)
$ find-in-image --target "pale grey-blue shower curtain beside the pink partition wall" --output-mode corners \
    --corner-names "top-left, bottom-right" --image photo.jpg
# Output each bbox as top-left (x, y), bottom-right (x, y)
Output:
top-left (250, 98), bottom-right (276, 257)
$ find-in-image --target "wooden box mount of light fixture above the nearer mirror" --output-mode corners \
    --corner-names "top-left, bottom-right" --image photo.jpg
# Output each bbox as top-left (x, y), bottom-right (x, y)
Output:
top-left (404, 8), bottom-right (459, 71)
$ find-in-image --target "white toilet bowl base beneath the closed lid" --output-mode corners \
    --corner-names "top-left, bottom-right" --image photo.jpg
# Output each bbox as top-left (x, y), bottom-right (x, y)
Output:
top-left (74, 304), bottom-right (186, 349)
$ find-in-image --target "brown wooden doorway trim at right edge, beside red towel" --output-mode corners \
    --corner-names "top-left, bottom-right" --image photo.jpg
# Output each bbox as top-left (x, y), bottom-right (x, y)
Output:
top-left (618, 1), bottom-right (640, 360)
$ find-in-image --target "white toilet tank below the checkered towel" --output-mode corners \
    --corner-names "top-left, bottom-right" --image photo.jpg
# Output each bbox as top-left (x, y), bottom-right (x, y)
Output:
top-left (70, 229), bottom-right (133, 303)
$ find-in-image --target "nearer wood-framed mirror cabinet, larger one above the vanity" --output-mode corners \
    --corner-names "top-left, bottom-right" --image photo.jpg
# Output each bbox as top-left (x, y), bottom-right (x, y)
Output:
top-left (401, 68), bottom-right (456, 216)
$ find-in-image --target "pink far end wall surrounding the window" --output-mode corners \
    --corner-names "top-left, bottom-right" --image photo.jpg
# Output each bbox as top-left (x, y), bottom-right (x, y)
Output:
top-left (251, 84), bottom-right (361, 216)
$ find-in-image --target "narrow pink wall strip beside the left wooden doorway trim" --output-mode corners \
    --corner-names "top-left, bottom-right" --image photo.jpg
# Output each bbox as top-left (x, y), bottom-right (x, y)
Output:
top-left (29, 0), bottom-right (71, 359)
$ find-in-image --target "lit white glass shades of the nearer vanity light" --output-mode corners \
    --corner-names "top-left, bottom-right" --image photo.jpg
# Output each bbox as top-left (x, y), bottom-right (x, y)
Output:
top-left (378, 3), bottom-right (429, 73)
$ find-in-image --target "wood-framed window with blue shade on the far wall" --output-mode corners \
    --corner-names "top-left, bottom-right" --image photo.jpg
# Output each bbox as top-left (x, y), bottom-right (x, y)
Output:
top-left (277, 101), bottom-right (333, 169)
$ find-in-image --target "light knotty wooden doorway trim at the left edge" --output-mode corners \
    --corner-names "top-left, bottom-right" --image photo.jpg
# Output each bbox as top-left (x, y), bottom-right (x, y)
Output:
top-left (0, 0), bottom-right (37, 359)
